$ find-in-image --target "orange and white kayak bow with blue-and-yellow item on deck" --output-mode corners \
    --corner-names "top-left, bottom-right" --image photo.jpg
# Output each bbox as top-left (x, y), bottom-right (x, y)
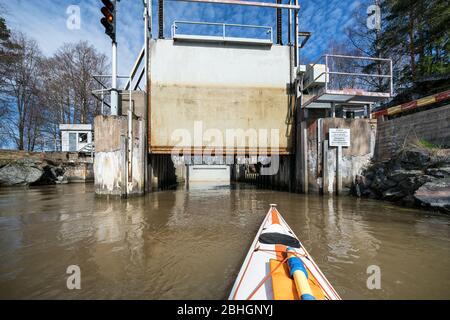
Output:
top-left (229, 204), bottom-right (341, 300)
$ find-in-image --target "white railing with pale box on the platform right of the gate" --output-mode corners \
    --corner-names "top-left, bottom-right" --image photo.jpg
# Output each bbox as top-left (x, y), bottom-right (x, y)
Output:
top-left (303, 54), bottom-right (393, 97)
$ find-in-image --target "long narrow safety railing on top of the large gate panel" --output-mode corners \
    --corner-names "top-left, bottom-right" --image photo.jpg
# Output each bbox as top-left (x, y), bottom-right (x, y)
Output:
top-left (172, 21), bottom-right (273, 44)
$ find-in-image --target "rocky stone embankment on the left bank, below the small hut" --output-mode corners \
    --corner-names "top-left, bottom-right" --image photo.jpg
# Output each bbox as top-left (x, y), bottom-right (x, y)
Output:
top-left (0, 150), bottom-right (93, 187)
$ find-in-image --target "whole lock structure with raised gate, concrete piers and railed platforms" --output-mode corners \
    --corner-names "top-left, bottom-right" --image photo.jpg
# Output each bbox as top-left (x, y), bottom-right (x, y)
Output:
top-left (94, 0), bottom-right (392, 196)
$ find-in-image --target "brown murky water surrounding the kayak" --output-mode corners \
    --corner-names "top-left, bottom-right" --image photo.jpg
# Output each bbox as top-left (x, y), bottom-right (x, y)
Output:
top-left (0, 184), bottom-right (450, 299)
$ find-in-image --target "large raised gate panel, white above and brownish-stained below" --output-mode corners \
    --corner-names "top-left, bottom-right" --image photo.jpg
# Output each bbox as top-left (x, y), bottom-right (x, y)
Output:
top-left (149, 40), bottom-right (291, 153)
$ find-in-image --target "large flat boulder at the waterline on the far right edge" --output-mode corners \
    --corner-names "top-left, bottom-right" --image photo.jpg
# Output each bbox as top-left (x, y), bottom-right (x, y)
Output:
top-left (414, 178), bottom-right (450, 213)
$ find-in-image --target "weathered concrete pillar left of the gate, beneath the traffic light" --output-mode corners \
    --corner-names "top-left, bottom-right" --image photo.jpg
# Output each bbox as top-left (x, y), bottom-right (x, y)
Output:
top-left (94, 115), bottom-right (145, 196)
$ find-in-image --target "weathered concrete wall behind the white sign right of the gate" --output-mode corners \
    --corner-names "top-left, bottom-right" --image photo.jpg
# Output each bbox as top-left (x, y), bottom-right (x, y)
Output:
top-left (296, 118), bottom-right (376, 194)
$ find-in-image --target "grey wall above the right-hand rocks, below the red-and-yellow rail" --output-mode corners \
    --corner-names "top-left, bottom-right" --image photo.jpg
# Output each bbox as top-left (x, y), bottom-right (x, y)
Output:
top-left (374, 105), bottom-right (450, 160)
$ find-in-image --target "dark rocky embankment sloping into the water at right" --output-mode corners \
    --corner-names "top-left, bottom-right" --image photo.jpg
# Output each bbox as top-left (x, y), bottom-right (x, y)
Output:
top-left (353, 146), bottom-right (450, 213)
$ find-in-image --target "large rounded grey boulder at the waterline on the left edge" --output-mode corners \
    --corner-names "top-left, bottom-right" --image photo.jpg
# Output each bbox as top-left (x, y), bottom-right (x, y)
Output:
top-left (0, 158), bottom-right (44, 186)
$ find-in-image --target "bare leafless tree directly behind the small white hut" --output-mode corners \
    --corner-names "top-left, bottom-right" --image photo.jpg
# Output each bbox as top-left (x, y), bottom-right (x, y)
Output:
top-left (41, 41), bottom-right (108, 150)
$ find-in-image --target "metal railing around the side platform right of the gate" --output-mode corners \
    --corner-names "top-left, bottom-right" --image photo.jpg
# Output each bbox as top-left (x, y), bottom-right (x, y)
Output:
top-left (303, 54), bottom-right (393, 96)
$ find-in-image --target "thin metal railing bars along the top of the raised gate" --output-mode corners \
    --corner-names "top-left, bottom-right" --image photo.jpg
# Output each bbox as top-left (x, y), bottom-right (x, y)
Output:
top-left (172, 21), bottom-right (273, 43)
